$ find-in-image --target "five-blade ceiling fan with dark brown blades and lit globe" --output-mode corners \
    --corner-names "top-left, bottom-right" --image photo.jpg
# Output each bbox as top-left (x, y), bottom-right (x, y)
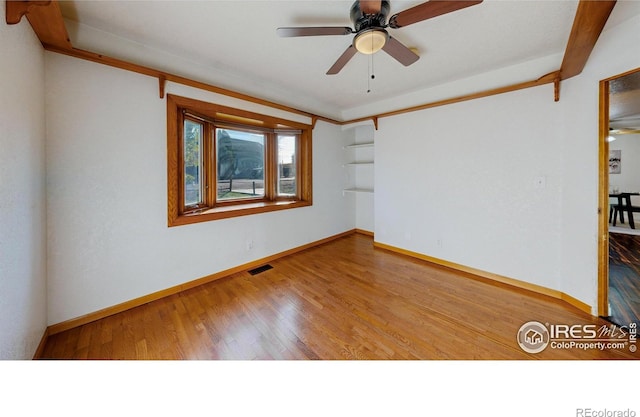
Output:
top-left (277, 0), bottom-right (482, 75)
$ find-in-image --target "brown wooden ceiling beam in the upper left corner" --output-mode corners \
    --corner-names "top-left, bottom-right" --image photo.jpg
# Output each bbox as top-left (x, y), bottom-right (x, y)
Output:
top-left (6, 0), bottom-right (71, 49)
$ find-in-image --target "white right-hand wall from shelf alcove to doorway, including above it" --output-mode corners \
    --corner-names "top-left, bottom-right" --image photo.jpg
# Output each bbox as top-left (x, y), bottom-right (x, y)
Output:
top-left (375, 8), bottom-right (640, 314)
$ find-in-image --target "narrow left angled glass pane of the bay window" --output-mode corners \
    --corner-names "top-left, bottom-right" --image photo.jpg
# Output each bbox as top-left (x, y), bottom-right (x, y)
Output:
top-left (183, 120), bottom-right (202, 207)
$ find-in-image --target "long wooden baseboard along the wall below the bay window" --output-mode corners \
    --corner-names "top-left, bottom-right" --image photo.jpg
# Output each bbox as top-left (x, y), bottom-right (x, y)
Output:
top-left (45, 230), bottom-right (355, 336)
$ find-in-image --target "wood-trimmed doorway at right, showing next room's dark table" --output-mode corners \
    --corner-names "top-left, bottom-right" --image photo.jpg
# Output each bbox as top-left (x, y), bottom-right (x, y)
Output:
top-left (598, 68), bottom-right (640, 326)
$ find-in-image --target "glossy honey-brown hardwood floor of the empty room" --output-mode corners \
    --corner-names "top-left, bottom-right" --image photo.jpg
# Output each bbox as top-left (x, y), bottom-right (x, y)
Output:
top-left (43, 234), bottom-right (640, 359)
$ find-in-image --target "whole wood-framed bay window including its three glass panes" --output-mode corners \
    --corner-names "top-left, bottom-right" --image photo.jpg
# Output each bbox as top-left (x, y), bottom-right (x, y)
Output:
top-left (167, 95), bottom-right (311, 226)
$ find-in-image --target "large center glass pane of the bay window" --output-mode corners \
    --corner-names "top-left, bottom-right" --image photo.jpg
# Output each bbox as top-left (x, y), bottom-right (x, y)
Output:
top-left (216, 129), bottom-right (265, 200)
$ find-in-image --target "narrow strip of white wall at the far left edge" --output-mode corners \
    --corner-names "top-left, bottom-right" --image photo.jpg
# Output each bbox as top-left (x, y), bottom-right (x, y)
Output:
top-left (0, 2), bottom-right (47, 359)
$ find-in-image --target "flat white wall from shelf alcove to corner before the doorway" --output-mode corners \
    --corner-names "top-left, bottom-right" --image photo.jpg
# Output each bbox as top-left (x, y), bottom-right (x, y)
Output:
top-left (375, 86), bottom-right (562, 288)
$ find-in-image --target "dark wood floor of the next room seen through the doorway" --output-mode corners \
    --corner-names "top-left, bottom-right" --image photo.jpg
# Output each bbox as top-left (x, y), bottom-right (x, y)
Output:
top-left (609, 233), bottom-right (640, 326)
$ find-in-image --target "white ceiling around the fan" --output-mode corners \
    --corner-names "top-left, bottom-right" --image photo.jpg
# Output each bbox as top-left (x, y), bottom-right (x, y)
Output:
top-left (60, 0), bottom-right (640, 120)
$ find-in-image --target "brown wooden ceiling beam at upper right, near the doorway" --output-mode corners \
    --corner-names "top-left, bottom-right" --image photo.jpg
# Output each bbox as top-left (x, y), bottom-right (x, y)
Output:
top-left (560, 0), bottom-right (616, 80)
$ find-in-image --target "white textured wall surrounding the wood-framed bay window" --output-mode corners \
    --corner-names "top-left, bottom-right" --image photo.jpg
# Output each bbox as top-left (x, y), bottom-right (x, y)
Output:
top-left (46, 53), bottom-right (355, 324)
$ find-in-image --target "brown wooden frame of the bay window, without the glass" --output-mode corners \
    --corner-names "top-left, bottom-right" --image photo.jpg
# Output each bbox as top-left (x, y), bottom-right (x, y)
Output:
top-left (167, 94), bottom-right (312, 227)
